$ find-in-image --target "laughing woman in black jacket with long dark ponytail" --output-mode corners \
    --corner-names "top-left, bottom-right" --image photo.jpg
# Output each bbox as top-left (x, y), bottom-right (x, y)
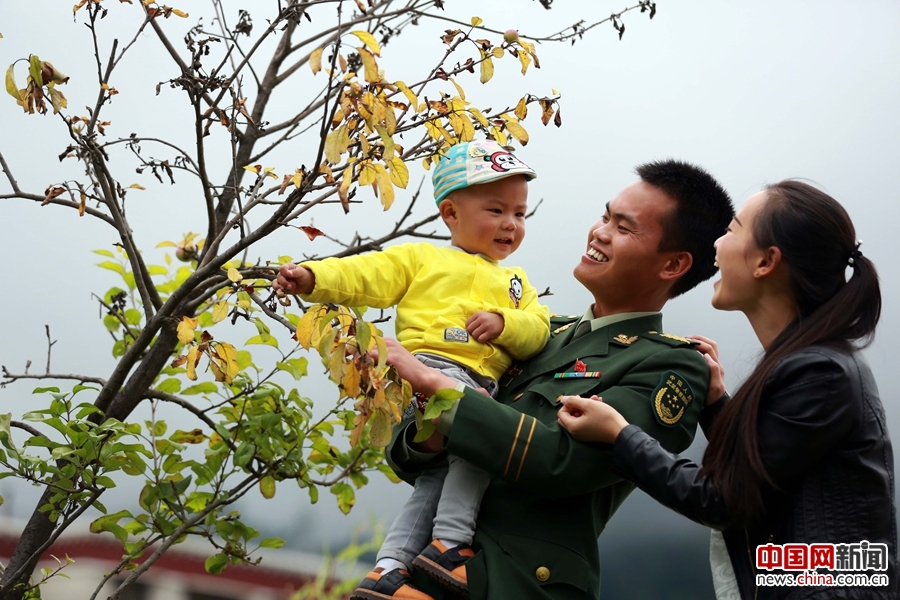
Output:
top-left (559, 180), bottom-right (900, 600)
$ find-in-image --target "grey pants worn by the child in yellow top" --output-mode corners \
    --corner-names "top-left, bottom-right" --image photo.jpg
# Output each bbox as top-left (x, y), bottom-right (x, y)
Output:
top-left (377, 352), bottom-right (497, 568)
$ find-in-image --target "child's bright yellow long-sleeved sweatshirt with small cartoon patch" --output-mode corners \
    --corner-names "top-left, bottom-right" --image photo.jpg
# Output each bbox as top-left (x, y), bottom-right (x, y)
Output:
top-left (303, 242), bottom-right (550, 381)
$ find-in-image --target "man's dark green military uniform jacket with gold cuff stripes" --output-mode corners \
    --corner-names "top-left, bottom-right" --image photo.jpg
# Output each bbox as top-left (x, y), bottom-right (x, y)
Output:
top-left (387, 313), bottom-right (709, 600)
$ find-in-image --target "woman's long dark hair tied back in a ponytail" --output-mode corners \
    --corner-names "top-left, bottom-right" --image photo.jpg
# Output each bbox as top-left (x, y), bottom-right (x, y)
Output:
top-left (703, 180), bottom-right (881, 524)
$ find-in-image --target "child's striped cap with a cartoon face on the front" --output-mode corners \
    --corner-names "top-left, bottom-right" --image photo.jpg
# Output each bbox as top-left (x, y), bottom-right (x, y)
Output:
top-left (431, 140), bottom-right (537, 204)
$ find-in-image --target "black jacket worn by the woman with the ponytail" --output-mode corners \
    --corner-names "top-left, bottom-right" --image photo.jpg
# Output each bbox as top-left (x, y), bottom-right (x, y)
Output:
top-left (613, 346), bottom-right (900, 600)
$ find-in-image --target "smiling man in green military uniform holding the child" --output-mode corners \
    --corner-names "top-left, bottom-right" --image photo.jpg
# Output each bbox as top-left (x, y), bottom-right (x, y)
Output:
top-left (376, 161), bottom-right (733, 600)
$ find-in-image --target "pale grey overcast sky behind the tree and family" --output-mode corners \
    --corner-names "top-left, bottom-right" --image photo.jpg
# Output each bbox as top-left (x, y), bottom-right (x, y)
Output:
top-left (0, 0), bottom-right (900, 556)
